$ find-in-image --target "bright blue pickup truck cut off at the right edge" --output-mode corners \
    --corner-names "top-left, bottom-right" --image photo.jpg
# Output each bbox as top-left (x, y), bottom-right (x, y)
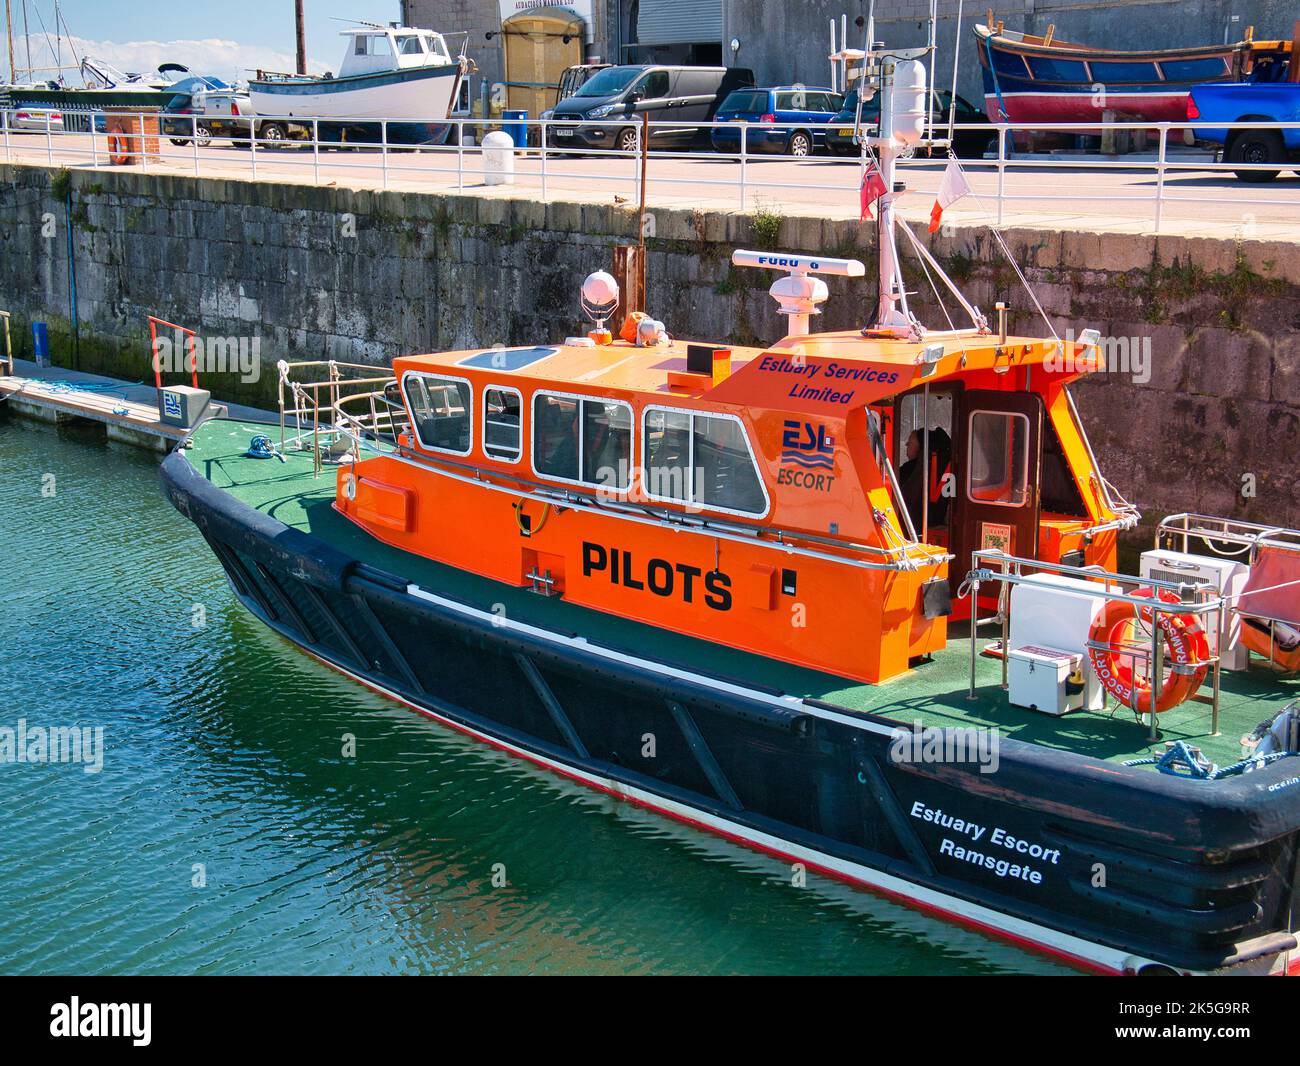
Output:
top-left (1187, 81), bottom-right (1300, 182)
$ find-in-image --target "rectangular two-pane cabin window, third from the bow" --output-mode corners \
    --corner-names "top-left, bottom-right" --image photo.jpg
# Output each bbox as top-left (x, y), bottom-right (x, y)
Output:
top-left (533, 393), bottom-right (632, 491)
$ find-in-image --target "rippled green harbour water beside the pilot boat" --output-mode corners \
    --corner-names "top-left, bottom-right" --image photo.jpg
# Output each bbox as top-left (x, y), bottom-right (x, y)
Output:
top-left (0, 411), bottom-right (1057, 974)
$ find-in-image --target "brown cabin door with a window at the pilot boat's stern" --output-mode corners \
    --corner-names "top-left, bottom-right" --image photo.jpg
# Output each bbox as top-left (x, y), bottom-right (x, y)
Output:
top-left (952, 390), bottom-right (1043, 581)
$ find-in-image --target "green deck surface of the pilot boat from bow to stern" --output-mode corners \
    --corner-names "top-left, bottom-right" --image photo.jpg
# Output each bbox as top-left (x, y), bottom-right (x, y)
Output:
top-left (186, 421), bottom-right (1300, 766)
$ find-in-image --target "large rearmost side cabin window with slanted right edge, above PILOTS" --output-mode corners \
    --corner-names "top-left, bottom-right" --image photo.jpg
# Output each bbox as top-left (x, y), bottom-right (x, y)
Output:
top-left (642, 407), bottom-right (767, 515)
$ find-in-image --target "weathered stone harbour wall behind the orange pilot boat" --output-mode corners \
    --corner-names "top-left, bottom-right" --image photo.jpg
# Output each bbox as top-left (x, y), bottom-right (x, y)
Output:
top-left (0, 165), bottom-right (1300, 542)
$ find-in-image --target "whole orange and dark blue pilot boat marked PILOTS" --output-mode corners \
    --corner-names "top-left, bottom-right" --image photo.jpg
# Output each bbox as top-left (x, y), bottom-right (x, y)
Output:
top-left (163, 35), bottom-right (1300, 974)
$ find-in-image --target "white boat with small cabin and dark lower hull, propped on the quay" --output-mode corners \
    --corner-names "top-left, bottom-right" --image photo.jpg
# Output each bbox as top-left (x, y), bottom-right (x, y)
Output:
top-left (248, 22), bottom-right (472, 143)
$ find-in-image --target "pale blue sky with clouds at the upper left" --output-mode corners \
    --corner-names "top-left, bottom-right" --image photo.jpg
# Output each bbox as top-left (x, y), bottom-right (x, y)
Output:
top-left (0, 0), bottom-right (416, 85)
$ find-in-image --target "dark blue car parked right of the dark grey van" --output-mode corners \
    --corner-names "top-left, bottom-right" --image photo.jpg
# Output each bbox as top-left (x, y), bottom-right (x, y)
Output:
top-left (711, 85), bottom-right (844, 156)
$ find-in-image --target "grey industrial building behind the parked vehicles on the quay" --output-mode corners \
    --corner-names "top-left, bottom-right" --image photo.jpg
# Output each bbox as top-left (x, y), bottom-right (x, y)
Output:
top-left (400, 0), bottom-right (1296, 113)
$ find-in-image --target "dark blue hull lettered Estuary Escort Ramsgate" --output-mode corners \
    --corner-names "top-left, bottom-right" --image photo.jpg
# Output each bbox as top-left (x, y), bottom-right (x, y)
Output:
top-left (163, 452), bottom-right (1300, 972)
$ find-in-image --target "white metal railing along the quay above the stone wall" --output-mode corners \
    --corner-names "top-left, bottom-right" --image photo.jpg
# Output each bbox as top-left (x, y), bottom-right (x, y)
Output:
top-left (0, 107), bottom-right (1300, 233)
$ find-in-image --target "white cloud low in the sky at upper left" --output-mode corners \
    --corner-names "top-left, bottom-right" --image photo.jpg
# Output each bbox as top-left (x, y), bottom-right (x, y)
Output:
top-left (14, 34), bottom-right (339, 86)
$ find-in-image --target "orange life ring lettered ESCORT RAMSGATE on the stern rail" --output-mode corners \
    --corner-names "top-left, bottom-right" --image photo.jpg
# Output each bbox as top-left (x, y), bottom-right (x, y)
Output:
top-left (1088, 589), bottom-right (1210, 714)
